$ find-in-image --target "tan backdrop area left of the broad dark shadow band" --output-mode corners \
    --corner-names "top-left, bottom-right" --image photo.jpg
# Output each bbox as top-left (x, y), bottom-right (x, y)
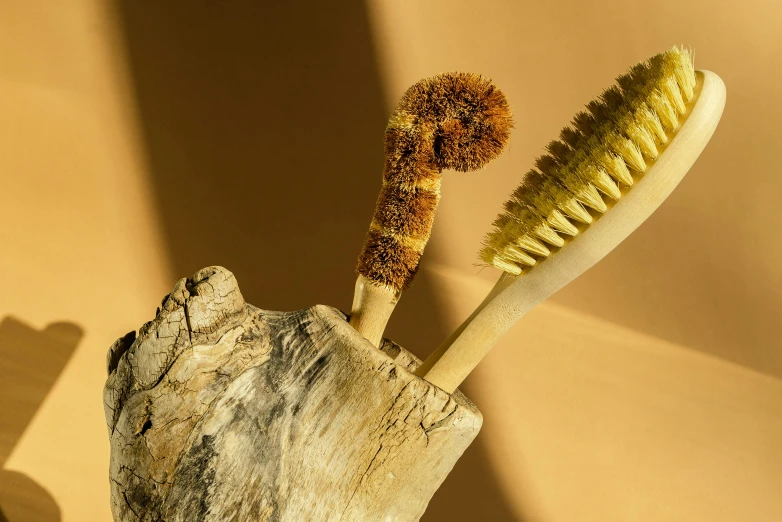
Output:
top-left (0, 1), bottom-right (171, 522)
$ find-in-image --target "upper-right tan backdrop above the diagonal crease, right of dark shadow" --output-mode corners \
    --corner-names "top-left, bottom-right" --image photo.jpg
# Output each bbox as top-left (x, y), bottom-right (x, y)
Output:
top-left (372, 1), bottom-right (782, 377)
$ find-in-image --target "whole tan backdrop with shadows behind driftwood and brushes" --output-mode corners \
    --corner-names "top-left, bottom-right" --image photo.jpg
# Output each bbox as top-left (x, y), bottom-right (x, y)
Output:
top-left (0, 0), bottom-right (782, 522)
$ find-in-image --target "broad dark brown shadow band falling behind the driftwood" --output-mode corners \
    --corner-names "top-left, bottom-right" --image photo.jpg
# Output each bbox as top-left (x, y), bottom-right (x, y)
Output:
top-left (116, 1), bottom-right (528, 522)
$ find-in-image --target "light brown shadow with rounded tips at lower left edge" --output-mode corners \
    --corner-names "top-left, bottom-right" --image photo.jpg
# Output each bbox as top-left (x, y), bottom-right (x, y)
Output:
top-left (0, 317), bottom-right (82, 522)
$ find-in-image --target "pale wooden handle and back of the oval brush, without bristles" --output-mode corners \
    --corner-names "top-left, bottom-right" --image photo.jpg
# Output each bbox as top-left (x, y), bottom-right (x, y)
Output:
top-left (416, 71), bottom-right (725, 392)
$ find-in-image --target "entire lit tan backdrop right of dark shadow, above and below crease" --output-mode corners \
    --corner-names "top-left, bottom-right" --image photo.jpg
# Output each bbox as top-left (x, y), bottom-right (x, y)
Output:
top-left (370, 0), bottom-right (782, 522)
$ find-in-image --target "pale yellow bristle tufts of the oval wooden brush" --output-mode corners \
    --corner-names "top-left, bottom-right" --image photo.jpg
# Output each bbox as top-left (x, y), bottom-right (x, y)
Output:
top-left (480, 47), bottom-right (696, 275)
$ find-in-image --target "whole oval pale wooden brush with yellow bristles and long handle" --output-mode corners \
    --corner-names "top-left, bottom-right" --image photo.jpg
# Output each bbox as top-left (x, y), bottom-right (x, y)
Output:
top-left (416, 47), bottom-right (725, 392)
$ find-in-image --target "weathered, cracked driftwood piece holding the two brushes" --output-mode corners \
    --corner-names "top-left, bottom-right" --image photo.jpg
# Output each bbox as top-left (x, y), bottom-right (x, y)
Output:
top-left (104, 267), bottom-right (482, 522)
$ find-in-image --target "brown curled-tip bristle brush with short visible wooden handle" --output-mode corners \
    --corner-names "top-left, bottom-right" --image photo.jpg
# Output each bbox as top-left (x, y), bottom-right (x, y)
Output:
top-left (350, 73), bottom-right (513, 346)
